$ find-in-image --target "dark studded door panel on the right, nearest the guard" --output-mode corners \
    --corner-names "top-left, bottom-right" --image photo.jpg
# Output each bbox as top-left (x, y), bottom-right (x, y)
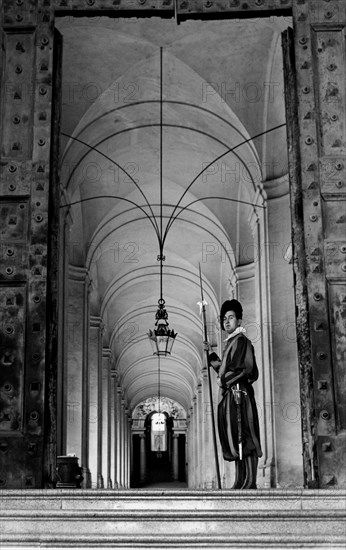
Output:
top-left (286, 0), bottom-right (346, 487)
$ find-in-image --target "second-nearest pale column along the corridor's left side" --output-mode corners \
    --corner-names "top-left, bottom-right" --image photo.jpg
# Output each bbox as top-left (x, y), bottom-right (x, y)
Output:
top-left (88, 316), bottom-right (103, 488)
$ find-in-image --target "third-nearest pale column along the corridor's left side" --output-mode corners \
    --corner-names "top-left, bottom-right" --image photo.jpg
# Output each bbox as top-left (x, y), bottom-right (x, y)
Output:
top-left (101, 348), bottom-right (111, 488)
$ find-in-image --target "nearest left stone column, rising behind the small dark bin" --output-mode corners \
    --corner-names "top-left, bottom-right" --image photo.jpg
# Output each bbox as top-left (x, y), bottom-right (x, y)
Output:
top-left (64, 265), bottom-right (91, 487)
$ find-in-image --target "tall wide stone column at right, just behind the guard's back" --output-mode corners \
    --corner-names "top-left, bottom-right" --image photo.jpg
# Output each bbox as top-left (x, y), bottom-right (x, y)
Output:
top-left (264, 176), bottom-right (303, 487)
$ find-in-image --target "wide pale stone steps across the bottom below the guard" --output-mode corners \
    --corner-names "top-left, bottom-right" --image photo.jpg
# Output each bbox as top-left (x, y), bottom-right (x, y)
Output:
top-left (0, 489), bottom-right (346, 550)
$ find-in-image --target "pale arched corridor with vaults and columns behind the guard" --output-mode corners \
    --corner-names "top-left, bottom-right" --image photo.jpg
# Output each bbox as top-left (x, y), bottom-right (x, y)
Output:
top-left (54, 14), bottom-right (302, 487)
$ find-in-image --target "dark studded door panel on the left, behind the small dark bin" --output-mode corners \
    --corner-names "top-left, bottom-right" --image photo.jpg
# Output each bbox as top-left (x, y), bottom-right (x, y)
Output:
top-left (0, 0), bottom-right (53, 488)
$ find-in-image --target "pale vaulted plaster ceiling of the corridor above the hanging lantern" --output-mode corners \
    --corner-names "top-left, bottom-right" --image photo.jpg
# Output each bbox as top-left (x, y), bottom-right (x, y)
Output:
top-left (58, 17), bottom-right (289, 410)
